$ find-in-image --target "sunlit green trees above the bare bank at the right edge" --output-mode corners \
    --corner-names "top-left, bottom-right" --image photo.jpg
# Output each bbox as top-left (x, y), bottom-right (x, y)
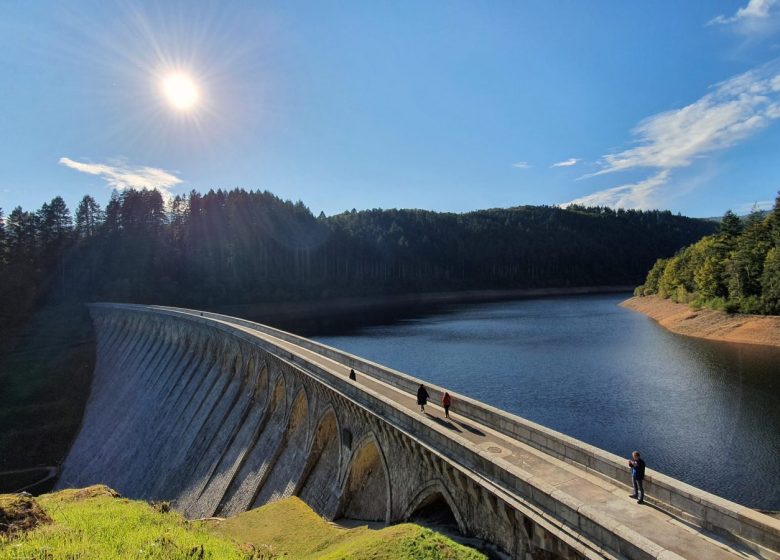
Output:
top-left (635, 193), bottom-right (780, 315)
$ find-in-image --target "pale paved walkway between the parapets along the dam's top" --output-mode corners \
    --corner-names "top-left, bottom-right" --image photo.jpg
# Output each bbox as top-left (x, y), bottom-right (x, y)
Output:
top-left (186, 310), bottom-right (758, 560)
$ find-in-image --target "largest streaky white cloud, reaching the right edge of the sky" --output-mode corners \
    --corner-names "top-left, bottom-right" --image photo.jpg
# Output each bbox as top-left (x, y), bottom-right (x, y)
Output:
top-left (591, 64), bottom-right (780, 176)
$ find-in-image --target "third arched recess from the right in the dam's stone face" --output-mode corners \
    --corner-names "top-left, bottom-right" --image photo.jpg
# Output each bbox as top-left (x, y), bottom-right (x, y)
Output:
top-left (295, 407), bottom-right (340, 518)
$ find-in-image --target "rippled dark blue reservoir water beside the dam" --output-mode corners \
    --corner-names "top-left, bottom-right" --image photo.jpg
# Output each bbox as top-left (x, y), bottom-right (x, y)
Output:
top-left (313, 294), bottom-right (780, 510)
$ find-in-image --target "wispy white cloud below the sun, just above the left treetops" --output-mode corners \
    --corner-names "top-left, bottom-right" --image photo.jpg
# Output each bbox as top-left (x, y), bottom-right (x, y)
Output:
top-left (59, 157), bottom-right (182, 198)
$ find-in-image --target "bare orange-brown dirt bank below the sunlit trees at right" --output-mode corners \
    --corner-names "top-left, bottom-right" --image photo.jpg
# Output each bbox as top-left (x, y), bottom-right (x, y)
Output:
top-left (620, 296), bottom-right (780, 347)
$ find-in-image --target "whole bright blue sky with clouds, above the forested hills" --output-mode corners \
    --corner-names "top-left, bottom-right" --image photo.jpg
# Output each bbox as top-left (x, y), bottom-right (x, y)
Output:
top-left (0, 0), bottom-right (780, 216)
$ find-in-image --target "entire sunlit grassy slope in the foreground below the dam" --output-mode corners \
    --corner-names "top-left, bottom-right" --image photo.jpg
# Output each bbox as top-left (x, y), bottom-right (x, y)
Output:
top-left (0, 486), bottom-right (484, 560)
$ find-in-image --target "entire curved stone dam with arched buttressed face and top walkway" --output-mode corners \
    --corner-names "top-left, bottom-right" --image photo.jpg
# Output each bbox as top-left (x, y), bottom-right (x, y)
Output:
top-left (58, 304), bottom-right (780, 560)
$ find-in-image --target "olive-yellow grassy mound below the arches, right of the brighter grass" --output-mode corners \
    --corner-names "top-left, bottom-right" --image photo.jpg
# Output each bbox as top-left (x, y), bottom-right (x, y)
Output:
top-left (209, 498), bottom-right (485, 560)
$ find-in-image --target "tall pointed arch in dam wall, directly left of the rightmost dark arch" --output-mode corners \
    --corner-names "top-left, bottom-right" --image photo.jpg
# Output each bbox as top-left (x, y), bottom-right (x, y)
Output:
top-left (338, 435), bottom-right (390, 521)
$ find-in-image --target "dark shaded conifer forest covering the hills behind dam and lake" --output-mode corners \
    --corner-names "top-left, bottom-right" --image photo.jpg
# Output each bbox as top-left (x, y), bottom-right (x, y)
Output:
top-left (0, 189), bottom-right (720, 332)
